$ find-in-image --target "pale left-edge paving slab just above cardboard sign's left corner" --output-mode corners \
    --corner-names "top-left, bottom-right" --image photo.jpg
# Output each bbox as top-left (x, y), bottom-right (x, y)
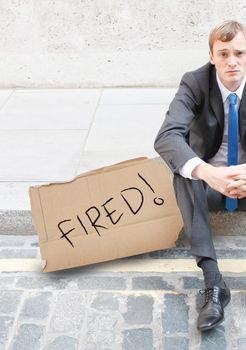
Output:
top-left (0, 130), bottom-right (87, 182)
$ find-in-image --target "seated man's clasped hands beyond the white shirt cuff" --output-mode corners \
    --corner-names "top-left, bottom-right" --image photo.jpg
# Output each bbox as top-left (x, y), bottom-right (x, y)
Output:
top-left (192, 163), bottom-right (240, 198)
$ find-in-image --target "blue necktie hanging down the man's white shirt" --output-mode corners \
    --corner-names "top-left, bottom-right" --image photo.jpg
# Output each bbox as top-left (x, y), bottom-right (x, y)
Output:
top-left (226, 94), bottom-right (238, 211)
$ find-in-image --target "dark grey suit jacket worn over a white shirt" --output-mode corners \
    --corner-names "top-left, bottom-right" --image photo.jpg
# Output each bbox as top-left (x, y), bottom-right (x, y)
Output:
top-left (154, 63), bottom-right (246, 173)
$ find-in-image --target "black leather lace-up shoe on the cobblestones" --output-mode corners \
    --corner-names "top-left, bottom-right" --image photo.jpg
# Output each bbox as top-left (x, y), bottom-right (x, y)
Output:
top-left (197, 284), bottom-right (231, 332)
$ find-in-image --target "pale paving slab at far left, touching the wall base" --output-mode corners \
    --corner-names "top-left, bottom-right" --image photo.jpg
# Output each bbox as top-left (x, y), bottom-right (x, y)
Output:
top-left (0, 89), bottom-right (101, 130)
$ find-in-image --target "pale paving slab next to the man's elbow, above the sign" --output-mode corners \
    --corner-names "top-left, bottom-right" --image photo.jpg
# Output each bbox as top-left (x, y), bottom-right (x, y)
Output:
top-left (85, 104), bottom-right (167, 151)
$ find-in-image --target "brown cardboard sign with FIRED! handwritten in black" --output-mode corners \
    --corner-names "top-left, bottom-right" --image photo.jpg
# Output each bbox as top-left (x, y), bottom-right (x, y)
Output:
top-left (29, 157), bottom-right (182, 272)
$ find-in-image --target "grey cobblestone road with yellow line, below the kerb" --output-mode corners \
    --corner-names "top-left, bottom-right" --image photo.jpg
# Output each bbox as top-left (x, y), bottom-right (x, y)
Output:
top-left (0, 235), bottom-right (246, 350)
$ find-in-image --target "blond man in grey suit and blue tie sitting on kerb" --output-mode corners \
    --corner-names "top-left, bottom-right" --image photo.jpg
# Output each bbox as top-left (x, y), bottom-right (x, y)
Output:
top-left (155, 21), bottom-right (246, 331)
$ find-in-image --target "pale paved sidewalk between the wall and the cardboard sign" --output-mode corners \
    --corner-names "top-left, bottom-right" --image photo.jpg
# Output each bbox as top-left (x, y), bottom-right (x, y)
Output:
top-left (0, 89), bottom-right (175, 210)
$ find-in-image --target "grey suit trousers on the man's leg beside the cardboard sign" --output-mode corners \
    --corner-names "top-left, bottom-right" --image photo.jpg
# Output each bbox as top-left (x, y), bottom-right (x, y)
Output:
top-left (173, 174), bottom-right (246, 266)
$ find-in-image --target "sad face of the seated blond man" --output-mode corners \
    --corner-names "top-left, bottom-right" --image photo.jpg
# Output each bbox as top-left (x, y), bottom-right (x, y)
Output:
top-left (209, 32), bottom-right (246, 91)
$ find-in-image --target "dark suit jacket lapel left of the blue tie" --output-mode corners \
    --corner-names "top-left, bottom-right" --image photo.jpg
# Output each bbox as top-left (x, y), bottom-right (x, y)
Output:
top-left (209, 66), bottom-right (225, 133)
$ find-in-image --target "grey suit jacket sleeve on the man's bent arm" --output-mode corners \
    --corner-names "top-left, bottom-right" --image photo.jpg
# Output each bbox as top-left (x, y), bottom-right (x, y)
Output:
top-left (154, 73), bottom-right (201, 173)
